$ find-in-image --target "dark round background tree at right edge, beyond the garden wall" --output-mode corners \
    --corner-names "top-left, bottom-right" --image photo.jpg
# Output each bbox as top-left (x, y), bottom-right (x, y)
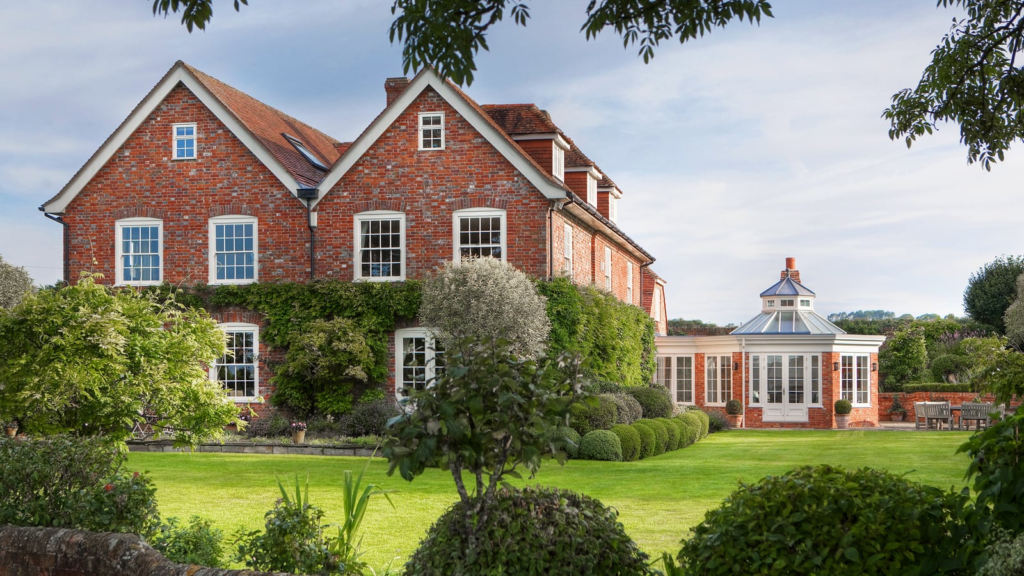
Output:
top-left (964, 255), bottom-right (1024, 334)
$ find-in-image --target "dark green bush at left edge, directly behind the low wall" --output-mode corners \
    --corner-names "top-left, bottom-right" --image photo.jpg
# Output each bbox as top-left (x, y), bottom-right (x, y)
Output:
top-left (0, 436), bottom-right (160, 538)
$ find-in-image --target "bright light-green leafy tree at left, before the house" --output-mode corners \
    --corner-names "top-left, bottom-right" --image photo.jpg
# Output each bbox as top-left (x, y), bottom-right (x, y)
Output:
top-left (0, 275), bottom-right (239, 447)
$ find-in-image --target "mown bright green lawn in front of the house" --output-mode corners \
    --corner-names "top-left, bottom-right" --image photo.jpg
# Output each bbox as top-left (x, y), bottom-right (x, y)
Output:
top-left (128, 430), bottom-right (968, 567)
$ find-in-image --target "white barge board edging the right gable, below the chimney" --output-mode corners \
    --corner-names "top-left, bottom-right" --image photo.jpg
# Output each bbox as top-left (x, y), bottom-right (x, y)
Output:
top-left (313, 68), bottom-right (566, 206)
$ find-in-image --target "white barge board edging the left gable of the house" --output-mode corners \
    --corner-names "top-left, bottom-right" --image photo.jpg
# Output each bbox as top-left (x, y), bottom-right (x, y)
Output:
top-left (43, 63), bottom-right (299, 214)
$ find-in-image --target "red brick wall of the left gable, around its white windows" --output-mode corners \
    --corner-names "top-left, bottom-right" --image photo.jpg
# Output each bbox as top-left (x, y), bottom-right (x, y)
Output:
top-left (65, 81), bottom-right (309, 284)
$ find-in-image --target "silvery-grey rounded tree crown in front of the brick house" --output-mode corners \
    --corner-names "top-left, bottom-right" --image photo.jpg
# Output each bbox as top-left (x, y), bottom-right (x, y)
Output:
top-left (420, 258), bottom-right (551, 357)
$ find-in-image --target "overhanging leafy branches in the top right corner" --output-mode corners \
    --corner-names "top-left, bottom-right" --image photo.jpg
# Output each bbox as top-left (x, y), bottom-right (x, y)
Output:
top-left (883, 0), bottom-right (1024, 170)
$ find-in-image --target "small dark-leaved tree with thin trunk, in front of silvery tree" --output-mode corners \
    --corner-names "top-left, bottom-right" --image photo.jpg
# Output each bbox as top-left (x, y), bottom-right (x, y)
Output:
top-left (383, 332), bottom-right (583, 541)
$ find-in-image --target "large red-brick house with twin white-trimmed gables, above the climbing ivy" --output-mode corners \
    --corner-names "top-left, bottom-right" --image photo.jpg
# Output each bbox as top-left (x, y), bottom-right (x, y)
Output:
top-left (40, 61), bottom-right (666, 402)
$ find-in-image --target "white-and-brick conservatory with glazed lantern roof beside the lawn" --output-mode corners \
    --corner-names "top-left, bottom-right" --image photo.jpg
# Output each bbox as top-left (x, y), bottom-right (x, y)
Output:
top-left (655, 258), bottom-right (886, 428)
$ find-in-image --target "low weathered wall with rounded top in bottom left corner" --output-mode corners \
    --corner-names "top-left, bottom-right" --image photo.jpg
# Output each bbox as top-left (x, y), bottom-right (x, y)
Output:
top-left (0, 526), bottom-right (288, 576)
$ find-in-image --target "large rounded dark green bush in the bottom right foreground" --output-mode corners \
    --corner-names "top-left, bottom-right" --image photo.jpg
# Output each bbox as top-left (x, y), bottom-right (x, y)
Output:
top-left (678, 465), bottom-right (981, 575)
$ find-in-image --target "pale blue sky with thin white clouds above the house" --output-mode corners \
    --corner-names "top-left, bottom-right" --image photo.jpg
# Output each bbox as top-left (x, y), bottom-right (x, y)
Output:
top-left (0, 0), bottom-right (1024, 323)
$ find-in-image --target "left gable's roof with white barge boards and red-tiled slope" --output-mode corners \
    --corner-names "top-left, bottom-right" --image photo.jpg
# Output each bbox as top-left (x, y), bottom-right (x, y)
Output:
top-left (43, 60), bottom-right (338, 213)
